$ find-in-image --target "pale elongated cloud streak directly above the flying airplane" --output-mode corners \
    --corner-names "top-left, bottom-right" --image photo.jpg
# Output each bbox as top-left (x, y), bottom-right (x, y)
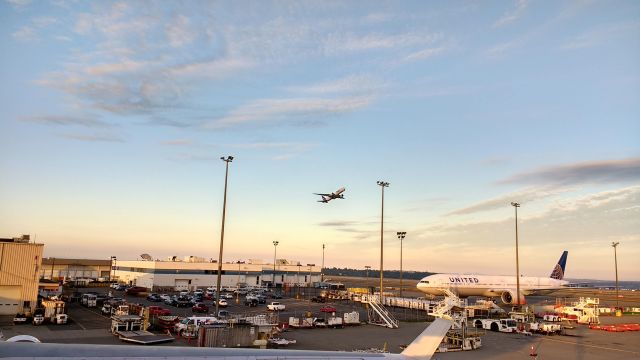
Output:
top-left (204, 96), bottom-right (373, 130)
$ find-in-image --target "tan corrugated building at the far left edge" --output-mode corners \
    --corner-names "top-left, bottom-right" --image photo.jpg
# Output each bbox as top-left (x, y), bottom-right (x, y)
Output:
top-left (0, 235), bottom-right (44, 315)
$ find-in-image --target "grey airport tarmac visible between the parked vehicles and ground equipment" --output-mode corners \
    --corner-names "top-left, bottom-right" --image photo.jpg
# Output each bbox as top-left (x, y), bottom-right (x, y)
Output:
top-left (0, 289), bottom-right (640, 360)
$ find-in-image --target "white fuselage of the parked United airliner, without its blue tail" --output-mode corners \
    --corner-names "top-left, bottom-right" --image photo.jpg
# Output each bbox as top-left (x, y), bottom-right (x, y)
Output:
top-left (417, 274), bottom-right (568, 297)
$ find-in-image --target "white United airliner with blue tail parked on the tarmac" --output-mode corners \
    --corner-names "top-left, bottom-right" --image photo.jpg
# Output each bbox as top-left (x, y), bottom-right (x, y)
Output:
top-left (417, 251), bottom-right (569, 305)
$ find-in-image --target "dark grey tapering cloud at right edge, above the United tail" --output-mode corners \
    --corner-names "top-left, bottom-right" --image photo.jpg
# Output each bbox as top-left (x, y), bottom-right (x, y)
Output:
top-left (498, 157), bottom-right (640, 185)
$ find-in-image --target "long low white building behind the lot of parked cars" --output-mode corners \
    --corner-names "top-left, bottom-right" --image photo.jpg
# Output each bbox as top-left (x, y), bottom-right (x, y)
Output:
top-left (114, 257), bottom-right (321, 291)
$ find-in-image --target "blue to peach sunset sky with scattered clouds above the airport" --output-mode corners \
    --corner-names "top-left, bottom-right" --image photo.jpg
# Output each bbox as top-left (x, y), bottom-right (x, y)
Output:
top-left (0, 0), bottom-right (640, 280)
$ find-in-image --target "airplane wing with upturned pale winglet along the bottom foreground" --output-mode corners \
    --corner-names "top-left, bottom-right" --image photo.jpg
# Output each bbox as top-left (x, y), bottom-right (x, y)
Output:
top-left (0, 318), bottom-right (453, 360)
